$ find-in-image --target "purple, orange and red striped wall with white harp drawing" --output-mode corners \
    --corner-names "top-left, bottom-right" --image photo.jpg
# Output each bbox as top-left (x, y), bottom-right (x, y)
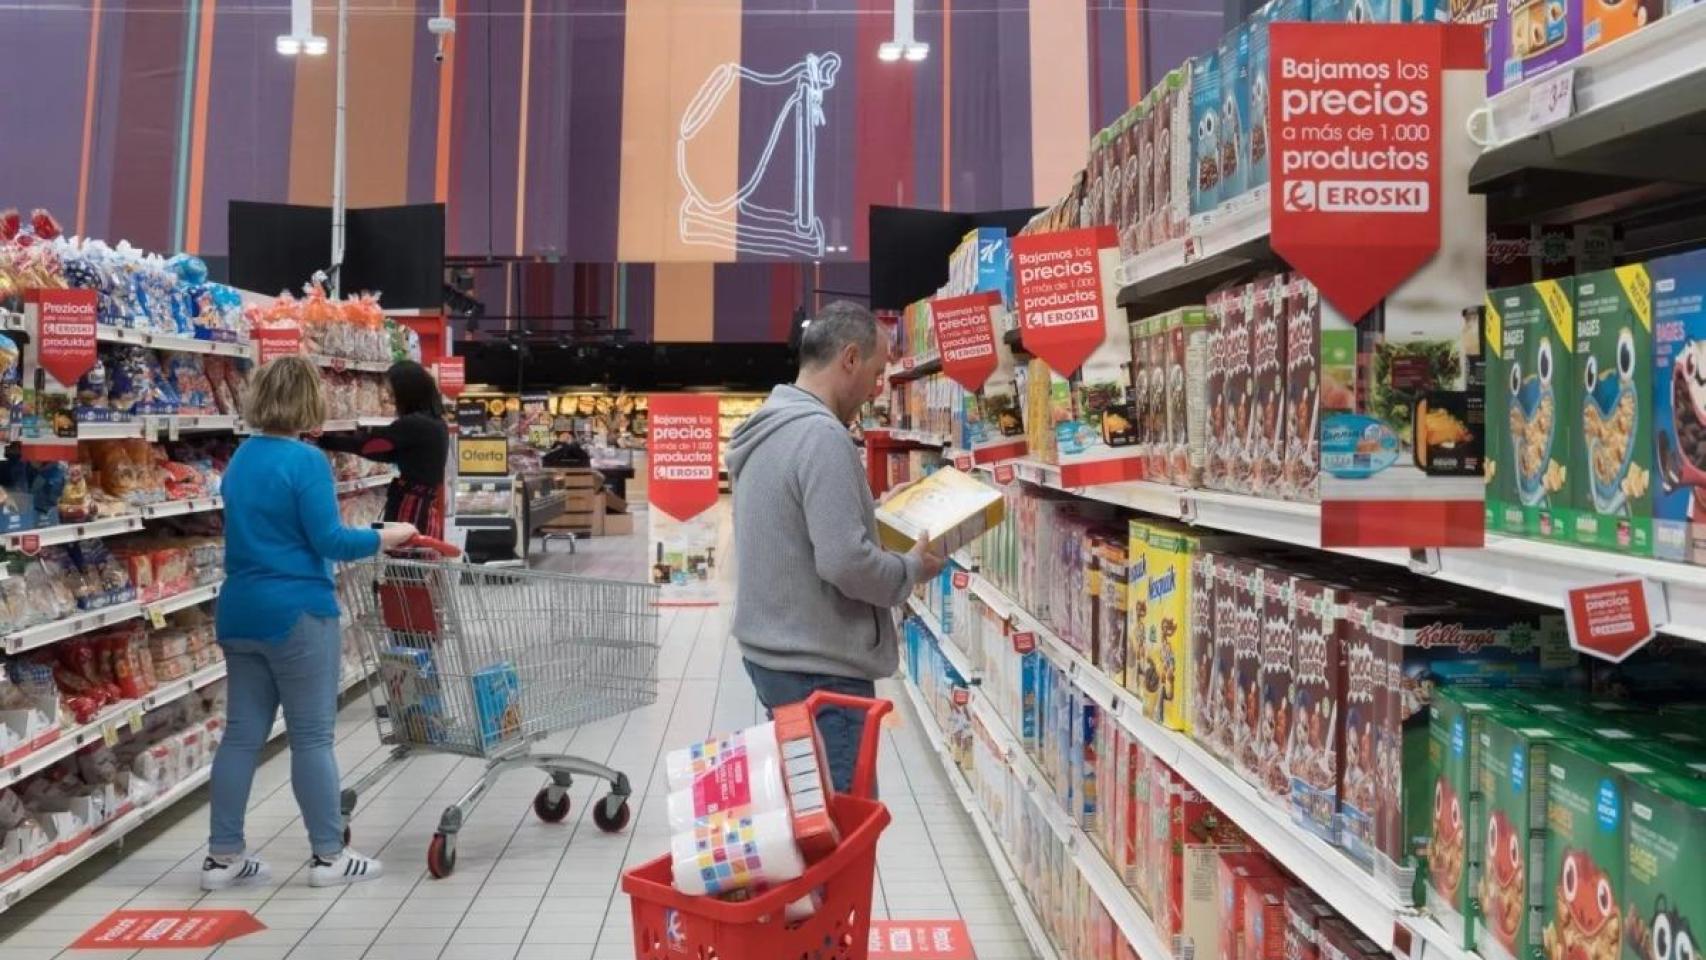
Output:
top-left (0, 0), bottom-right (1220, 341)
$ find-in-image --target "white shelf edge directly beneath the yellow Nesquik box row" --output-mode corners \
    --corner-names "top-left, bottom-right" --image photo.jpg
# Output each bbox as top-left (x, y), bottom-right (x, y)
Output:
top-left (971, 576), bottom-right (1476, 960)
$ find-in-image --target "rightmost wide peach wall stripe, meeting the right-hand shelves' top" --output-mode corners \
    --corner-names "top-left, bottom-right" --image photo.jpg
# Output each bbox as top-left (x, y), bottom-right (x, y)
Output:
top-left (1029, 3), bottom-right (1090, 206)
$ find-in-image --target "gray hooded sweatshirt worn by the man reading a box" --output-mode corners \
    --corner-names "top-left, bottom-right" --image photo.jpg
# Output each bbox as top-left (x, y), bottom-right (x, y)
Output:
top-left (728, 384), bottom-right (918, 680)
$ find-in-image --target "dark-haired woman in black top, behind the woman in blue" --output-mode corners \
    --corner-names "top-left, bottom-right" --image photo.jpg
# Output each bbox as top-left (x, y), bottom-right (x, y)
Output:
top-left (317, 360), bottom-right (450, 539)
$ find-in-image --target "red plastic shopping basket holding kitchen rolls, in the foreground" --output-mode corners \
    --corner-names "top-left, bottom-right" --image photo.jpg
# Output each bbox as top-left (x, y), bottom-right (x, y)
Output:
top-left (623, 692), bottom-right (894, 960)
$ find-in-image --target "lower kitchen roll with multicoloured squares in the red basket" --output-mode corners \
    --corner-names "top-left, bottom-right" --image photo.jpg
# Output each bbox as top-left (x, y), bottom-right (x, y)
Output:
top-left (670, 808), bottom-right (805, 897)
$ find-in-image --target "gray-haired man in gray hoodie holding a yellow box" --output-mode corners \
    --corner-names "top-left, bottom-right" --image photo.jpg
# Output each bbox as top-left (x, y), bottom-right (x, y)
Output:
top-left (728, 300), bottom-right (943, 791)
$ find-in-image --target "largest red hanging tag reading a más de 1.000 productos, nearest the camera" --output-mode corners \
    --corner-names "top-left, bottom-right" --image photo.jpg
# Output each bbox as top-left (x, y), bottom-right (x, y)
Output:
top-left (1269, 22), bottom-right (1483, 317)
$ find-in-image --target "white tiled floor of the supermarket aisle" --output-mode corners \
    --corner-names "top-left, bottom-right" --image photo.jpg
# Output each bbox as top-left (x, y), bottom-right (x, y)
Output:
top-left (0, 515), bottom-right (1034, 960)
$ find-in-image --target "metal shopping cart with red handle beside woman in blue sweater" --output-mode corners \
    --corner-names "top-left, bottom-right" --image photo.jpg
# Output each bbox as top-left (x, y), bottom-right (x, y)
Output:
top-left (343, 539), bottom-right (659, 878)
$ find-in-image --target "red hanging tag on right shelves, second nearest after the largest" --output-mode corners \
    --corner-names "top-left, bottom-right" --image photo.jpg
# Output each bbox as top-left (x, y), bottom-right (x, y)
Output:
top-left (1013, 227), bottom-right (1119, 377)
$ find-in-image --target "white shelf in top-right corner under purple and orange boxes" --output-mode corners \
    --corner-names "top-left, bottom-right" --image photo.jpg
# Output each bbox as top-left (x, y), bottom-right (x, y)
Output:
top-left (1469, 7), bottom-right (1706, 188)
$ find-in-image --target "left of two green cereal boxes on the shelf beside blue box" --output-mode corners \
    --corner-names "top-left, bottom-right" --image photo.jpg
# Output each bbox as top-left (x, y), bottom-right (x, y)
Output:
top-left (1483, 280), bottom-right (1576, 541)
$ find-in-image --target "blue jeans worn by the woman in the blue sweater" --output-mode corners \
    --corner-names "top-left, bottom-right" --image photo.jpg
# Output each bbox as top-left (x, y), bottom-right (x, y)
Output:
top-left (208, 614), bottom-right (343, 858)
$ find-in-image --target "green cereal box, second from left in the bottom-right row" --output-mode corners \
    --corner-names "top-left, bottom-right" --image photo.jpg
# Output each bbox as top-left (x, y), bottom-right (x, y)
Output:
top-left (1474, 711), bottom-right (1563, 960)
